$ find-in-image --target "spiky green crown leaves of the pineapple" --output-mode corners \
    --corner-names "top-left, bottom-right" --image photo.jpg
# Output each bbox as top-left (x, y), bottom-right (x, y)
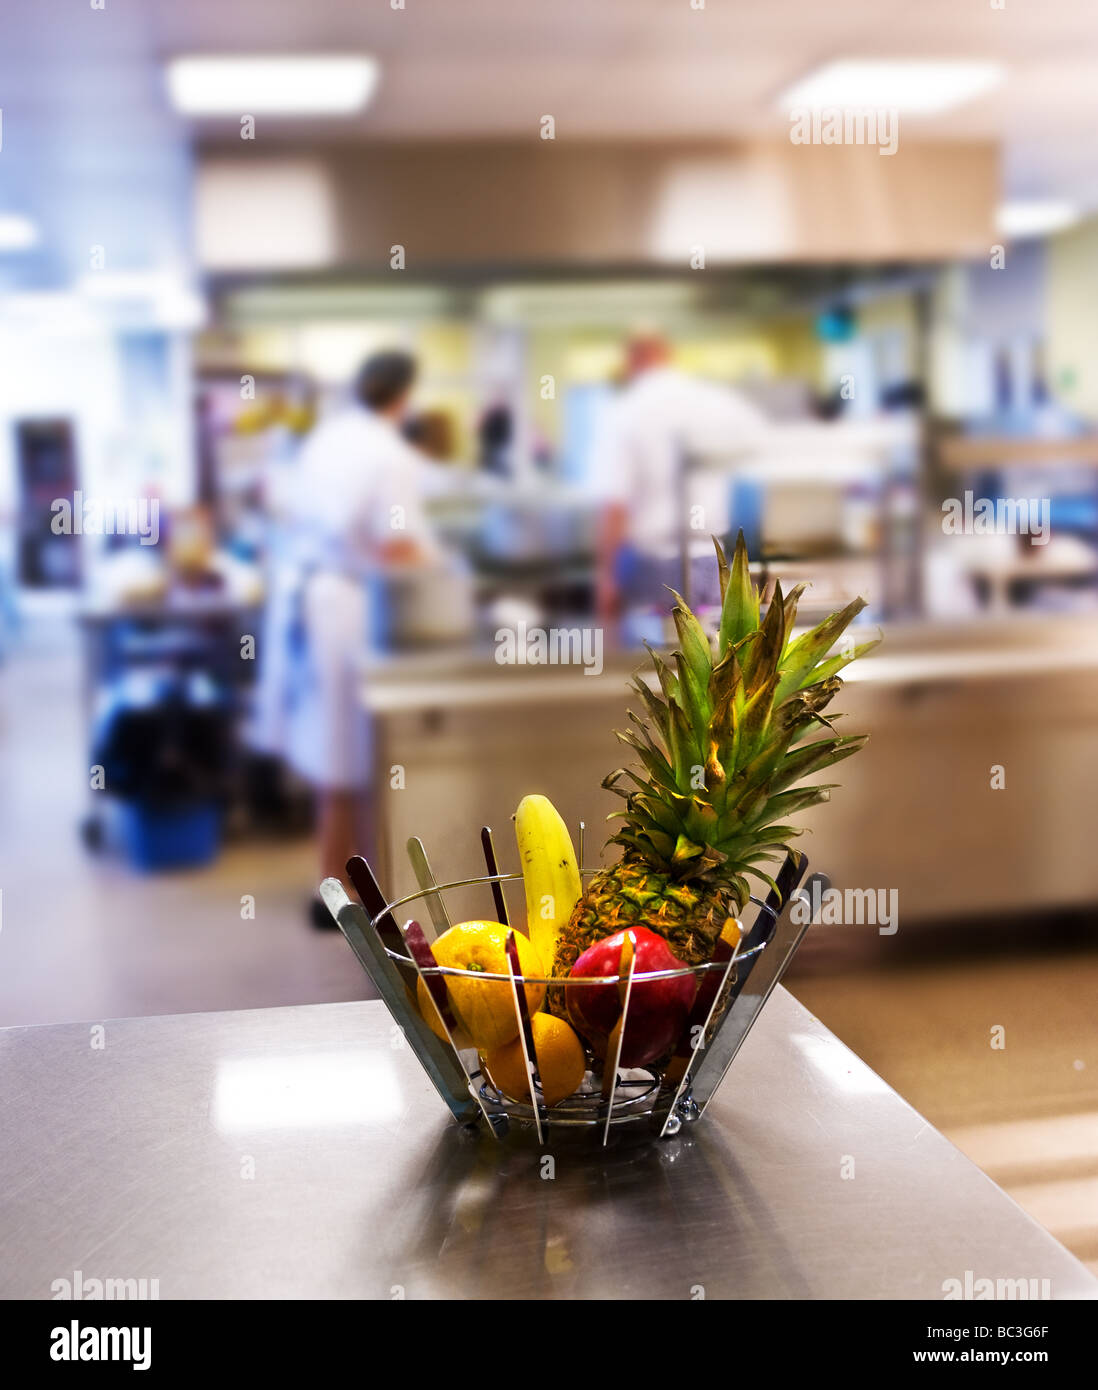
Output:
top-left (603, 532), bottom-right (880, 892)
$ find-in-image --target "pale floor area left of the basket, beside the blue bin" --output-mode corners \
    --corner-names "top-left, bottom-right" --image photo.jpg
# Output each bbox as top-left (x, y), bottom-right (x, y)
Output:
top-left (0, 621), bottom-right (368, 1026)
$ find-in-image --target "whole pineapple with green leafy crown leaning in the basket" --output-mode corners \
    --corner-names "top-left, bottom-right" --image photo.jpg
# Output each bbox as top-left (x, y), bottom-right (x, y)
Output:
top-left (553, 532), bottom-right (880, 979)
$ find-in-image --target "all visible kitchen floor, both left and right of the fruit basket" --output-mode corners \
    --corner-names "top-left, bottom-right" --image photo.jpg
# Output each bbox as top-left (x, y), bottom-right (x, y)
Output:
top-left (0, 623), bottom-right (1098, 1272)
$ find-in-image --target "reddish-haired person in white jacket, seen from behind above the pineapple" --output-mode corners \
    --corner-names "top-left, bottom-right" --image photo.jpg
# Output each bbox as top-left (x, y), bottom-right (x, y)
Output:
top-left (592, 334), bottom-right (767, 620)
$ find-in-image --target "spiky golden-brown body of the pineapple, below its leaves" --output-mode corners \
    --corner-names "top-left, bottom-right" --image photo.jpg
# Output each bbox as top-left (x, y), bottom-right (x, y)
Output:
top-left (553, 853), bottom-right (742, 979)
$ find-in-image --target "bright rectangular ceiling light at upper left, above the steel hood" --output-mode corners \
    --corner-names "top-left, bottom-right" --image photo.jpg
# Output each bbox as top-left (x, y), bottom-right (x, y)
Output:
top-left (168, 56), bottom-right (378, 115)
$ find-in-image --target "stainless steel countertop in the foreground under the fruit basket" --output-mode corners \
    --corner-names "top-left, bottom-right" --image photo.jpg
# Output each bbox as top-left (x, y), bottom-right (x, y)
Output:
top-left (0, 990), bottom-right (1098, 1298)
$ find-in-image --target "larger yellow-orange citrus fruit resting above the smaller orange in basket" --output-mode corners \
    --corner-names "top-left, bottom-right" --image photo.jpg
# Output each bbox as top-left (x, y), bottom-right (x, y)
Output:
top-left (416, 922), bottom-right (545, 1051)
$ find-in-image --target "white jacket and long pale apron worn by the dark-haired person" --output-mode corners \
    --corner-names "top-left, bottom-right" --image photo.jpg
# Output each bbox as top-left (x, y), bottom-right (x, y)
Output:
top-left (253, 406), bottom-right (441, 790)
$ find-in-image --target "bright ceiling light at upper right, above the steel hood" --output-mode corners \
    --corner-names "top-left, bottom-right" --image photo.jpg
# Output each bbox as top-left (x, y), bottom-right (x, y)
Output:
top-left (781, 58), bottom-right (1005, 115)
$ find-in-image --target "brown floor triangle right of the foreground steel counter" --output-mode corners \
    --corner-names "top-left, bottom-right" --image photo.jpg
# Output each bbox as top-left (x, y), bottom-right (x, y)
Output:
top-left (789, 951), bottom-right (1098, 1273)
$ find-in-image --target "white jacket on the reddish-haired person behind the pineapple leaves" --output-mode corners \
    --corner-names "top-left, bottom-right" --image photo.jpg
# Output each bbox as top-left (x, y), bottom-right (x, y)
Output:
top-left (591, 367), bottom-right (767, 560)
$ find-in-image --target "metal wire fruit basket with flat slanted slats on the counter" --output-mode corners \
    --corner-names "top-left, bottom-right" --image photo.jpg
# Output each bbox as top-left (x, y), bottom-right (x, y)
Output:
top-left (321, 824), bottom-right (828, 1145)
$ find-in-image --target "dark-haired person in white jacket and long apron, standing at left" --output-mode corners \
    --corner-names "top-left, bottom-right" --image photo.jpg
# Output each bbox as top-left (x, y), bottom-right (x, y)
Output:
top-left (256, 352), bottom-right (438, 926)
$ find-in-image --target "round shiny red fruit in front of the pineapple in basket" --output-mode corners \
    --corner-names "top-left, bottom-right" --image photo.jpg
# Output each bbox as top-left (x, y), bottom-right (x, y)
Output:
top-left (566, 927), bottom-right (698, 1066)
